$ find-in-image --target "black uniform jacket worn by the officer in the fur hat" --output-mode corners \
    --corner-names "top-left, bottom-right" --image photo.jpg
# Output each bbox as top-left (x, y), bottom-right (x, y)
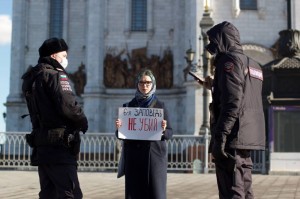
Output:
top-left (22, 56), bottom-right (88, 165)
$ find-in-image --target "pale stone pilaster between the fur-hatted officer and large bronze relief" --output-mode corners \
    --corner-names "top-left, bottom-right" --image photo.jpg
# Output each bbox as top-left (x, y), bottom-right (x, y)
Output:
top-left (82, 0), bottom-right (106, 132)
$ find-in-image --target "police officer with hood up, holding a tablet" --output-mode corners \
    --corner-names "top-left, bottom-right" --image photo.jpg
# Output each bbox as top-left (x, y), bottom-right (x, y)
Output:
top-left (206, 21), bottom-right (265, 199)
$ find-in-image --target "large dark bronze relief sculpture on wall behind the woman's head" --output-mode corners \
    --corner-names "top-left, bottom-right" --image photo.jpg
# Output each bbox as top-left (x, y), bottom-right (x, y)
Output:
top-left (103, 47), bottom-right (173, 88)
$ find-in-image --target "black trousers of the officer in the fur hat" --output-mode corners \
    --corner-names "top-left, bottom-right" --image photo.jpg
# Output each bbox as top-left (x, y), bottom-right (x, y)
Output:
top-left (38, 165), bottom-right (82, 199)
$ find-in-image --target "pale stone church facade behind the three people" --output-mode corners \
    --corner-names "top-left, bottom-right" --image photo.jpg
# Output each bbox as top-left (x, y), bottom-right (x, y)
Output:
top-left (6, 0), bottom-right (300, 134)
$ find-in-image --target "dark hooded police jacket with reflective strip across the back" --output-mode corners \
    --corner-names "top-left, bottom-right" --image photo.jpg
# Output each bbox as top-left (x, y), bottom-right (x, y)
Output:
top-left (207, 22), bottom-right (265, 150)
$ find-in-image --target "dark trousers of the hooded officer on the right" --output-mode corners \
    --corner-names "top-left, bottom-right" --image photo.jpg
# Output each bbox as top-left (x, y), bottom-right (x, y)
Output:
top-left (215, 149), bottom-right (254, 199)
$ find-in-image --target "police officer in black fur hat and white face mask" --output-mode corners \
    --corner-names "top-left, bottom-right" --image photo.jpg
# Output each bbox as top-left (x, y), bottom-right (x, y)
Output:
top-left (22, 38), bottom-right (88, 199)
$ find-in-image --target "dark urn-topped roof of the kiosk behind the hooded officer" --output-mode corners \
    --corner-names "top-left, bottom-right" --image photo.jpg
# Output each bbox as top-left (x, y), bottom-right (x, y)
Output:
top-left (263, 29), bottom-right (300, 101)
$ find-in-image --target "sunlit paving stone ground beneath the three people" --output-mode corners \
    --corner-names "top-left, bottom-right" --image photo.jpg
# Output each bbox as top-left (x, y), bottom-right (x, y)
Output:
top-left (0, 170), bottom-right (300, 199)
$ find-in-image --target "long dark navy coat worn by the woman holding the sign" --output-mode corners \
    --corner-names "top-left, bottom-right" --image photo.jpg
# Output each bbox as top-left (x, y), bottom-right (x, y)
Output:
top-left (118, 98), bottom-right (173, 199)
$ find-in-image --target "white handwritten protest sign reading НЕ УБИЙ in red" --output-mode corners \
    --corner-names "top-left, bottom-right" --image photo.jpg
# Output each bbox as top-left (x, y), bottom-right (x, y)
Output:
top-left (118, 107), bottom-right (164, 140)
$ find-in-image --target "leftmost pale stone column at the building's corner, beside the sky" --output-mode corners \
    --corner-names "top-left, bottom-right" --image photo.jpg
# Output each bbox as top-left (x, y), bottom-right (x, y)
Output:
top-left (5, 0), bottom-right (30, 131)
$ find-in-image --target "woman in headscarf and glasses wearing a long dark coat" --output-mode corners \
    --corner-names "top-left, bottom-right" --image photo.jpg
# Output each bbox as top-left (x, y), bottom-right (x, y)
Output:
top-left (116, 70), bottom-right (173, 199)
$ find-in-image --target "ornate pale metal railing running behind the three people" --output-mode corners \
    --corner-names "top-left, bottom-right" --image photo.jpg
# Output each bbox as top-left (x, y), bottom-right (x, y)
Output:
top-left (0, 132), bottom-right (266, 173)
